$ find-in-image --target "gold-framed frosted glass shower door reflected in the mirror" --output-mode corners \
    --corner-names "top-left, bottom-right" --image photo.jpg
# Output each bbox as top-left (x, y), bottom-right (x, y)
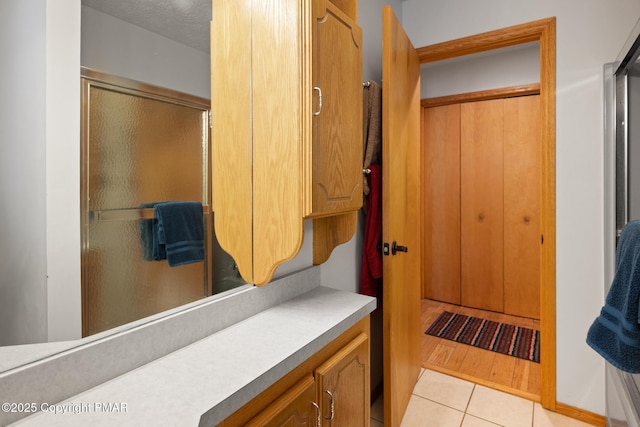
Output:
top-left (81, 71), bottom-right (211, 336)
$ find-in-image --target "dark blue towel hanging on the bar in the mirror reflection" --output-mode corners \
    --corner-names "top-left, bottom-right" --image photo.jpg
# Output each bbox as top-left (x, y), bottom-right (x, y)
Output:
top-left (153, 202), bottom-right (204, 267)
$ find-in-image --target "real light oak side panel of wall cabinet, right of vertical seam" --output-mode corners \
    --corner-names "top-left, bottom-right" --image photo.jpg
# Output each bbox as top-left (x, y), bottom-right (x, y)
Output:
top-left (250, 0), bottom-right (305, 285)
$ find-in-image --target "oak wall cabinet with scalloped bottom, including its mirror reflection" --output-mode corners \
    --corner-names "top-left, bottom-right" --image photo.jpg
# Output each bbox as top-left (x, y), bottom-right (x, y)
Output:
top-left (211, 0), bottom-right (362, 285)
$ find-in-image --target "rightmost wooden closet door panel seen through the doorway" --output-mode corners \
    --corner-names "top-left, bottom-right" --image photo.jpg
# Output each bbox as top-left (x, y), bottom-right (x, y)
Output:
top-left (504, 95), bottom-right (541, 319)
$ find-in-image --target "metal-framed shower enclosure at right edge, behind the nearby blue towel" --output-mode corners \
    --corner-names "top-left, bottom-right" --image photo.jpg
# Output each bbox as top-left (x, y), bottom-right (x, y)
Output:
top-left (604, 17), bottom-right (640, 427)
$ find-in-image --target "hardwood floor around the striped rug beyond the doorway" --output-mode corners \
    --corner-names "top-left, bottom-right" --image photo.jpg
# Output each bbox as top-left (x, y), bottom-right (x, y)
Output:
top-left (421, 299), bottom-right (540, 402)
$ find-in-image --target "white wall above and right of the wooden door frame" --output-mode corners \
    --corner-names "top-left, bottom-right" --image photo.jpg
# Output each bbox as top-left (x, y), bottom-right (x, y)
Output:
top-left (403, 0), bottom-right (640, 414)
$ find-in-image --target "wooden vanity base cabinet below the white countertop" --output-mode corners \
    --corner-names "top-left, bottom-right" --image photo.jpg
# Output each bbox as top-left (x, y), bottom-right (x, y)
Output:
top-left (219, 316), bottom-right (371, 427)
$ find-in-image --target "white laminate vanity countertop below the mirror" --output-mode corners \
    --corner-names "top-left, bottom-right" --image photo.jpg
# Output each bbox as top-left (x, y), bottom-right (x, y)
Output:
top-left (14, 287), bottom-right (376, 427)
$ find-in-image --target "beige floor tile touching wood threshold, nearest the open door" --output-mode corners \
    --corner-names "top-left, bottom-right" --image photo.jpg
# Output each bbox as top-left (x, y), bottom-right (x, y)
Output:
top-left (413, 369), bottom-right (474, 412)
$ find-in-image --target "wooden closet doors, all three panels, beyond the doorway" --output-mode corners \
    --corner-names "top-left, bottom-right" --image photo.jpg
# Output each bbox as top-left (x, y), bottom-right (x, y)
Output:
top-left (423, 96), bottom-right (540, 318)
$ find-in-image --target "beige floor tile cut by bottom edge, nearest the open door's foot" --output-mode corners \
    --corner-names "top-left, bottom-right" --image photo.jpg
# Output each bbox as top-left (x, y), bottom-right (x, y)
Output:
top-left (400, 395), bottom-right (464, 427)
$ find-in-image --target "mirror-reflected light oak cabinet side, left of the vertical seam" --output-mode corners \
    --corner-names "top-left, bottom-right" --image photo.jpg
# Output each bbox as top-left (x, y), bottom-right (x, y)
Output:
top-left (211, 0), bottom-right (253, 283)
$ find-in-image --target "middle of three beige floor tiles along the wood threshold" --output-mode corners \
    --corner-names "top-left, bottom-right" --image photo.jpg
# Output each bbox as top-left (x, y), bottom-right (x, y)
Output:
top-left (467, 385), bottom-right (533, 427)
